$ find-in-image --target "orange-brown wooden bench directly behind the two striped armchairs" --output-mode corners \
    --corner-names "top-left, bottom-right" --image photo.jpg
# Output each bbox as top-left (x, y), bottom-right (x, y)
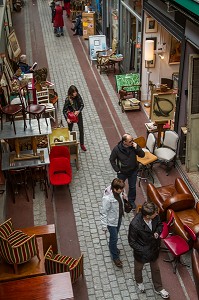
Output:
top-left (20, 224), bottom-right (57, 254)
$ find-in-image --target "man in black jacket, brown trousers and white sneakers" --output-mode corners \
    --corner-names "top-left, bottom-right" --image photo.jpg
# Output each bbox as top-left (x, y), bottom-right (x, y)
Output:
top-left (128, 202), bottom-right (169, 299)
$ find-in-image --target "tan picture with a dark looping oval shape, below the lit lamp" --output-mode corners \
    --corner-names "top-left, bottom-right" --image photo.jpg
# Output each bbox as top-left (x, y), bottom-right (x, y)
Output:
top-left (150, 93), bottom-right (176, 122)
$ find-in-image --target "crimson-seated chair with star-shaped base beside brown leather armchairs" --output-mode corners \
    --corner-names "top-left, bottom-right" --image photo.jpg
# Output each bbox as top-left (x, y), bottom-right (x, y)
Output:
top-left (161, 214), bottom-right (196, 274)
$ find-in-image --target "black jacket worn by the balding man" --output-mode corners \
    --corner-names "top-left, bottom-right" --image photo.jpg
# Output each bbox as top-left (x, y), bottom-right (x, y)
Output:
top-left (110, 141), bottom-right (145, 174)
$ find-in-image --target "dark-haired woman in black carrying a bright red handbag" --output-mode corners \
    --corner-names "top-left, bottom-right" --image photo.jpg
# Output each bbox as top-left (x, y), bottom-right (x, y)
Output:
top-left (63, 85), bottom-right (86, 151)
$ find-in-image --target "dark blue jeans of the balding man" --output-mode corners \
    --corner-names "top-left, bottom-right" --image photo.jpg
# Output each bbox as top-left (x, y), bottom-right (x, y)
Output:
top-left (117, 170), bottom-right (138, 208)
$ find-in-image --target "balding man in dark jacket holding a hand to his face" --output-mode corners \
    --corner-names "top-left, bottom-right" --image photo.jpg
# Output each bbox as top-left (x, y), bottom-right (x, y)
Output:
top-left (110, 133), bottom-right (145, 209)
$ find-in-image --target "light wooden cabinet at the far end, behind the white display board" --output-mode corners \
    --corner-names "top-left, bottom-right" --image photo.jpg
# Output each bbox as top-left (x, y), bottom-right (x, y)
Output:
top-left (82, 12), bottom-right (96, 39)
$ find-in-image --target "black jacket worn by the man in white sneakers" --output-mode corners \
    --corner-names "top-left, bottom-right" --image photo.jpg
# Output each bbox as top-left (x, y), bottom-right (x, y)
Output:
top-left (128, 213), bottom-right (162, 263)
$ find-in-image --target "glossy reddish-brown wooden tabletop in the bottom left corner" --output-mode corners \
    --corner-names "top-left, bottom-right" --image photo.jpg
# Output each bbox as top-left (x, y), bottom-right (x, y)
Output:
top-left (0, 272), bottom-right (74, 300)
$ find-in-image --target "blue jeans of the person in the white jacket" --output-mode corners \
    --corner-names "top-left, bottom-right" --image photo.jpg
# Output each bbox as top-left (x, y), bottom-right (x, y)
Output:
top-left (107, 218), bottom-right (122, 260)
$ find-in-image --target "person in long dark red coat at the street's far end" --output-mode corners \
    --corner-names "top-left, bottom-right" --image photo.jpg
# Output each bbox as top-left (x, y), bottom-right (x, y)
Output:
top-left (53, 2), bottom-right (64, 37)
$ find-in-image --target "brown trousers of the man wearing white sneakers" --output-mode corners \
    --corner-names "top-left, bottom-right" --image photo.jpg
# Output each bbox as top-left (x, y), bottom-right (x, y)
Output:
top-left (134, 259), bottom-right (162, 292)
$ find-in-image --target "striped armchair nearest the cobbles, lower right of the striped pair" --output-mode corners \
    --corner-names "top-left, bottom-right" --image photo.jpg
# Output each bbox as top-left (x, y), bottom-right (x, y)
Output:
top-left (45, 246), bottom-right (83, 283)
